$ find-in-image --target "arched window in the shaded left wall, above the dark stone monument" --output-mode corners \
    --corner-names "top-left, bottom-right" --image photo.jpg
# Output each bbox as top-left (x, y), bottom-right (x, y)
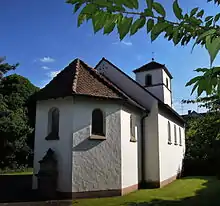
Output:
top-left (46, 107), bottom-right (60, 140)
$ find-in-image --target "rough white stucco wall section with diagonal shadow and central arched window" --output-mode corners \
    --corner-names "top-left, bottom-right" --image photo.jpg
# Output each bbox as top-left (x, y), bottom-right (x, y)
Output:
top-left (72, 99), bottom-right (121, 192)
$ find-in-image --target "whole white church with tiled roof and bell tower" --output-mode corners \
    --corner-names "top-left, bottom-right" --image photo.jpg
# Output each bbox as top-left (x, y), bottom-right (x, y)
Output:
top-left (33, 58), bottom-right (185, 198)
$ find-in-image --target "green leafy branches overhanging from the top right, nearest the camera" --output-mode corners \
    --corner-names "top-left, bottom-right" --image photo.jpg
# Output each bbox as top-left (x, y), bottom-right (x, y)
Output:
top-left (67, 0), bottom-right (220, 96)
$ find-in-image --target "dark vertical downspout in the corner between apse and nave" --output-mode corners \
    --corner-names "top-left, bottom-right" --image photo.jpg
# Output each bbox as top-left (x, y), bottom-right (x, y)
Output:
top-left (140, 111), bottom-right (149, 188)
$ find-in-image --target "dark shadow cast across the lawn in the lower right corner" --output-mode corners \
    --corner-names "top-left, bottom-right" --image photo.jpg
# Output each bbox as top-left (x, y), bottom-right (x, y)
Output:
top-left (126, 177), bottom-right (220, 206)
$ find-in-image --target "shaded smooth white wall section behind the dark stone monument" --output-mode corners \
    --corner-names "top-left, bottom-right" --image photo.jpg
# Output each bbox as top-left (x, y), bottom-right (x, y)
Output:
top-left (33, 97), bottom-right (73, 192)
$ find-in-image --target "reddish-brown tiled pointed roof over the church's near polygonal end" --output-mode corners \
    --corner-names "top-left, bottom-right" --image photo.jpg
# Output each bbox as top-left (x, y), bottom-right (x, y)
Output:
top-left (37, 59), bottom-right (126, 100)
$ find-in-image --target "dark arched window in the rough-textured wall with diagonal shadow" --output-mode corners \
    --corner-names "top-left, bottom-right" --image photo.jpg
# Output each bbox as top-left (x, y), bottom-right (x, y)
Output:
top-left (92, 109), bottom-right (104, 136)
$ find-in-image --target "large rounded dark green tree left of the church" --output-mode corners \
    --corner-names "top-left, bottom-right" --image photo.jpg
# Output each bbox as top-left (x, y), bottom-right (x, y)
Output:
top-left (0, 74), bottom-right (39, 168)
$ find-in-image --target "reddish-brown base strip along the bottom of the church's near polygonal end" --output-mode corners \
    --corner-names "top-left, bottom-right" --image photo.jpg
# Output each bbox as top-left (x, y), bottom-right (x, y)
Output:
top-left (59, 184), bottom-right (138, 199)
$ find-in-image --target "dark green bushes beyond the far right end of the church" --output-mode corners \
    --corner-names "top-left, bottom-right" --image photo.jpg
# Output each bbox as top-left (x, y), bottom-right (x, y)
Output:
top-left (184, 112), bottom-right (220, 176)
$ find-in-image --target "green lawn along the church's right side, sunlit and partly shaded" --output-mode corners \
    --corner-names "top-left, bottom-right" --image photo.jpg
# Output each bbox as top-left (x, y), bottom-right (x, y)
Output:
top-left (73, 177), bottom-right (220, 206)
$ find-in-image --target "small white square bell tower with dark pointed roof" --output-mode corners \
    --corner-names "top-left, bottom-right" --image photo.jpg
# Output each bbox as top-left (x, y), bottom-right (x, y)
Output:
top-left (133, 58), bottom-right (173, 107)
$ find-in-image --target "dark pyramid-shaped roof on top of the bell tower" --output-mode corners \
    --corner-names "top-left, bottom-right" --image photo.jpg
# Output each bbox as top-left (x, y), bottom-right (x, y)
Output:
top-left (133, 61), bottom-right (173, 79)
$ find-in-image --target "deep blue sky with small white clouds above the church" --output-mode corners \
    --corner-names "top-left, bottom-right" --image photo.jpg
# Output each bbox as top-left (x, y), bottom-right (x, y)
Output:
top-left (0, 0), bottom-right (220, 113)
